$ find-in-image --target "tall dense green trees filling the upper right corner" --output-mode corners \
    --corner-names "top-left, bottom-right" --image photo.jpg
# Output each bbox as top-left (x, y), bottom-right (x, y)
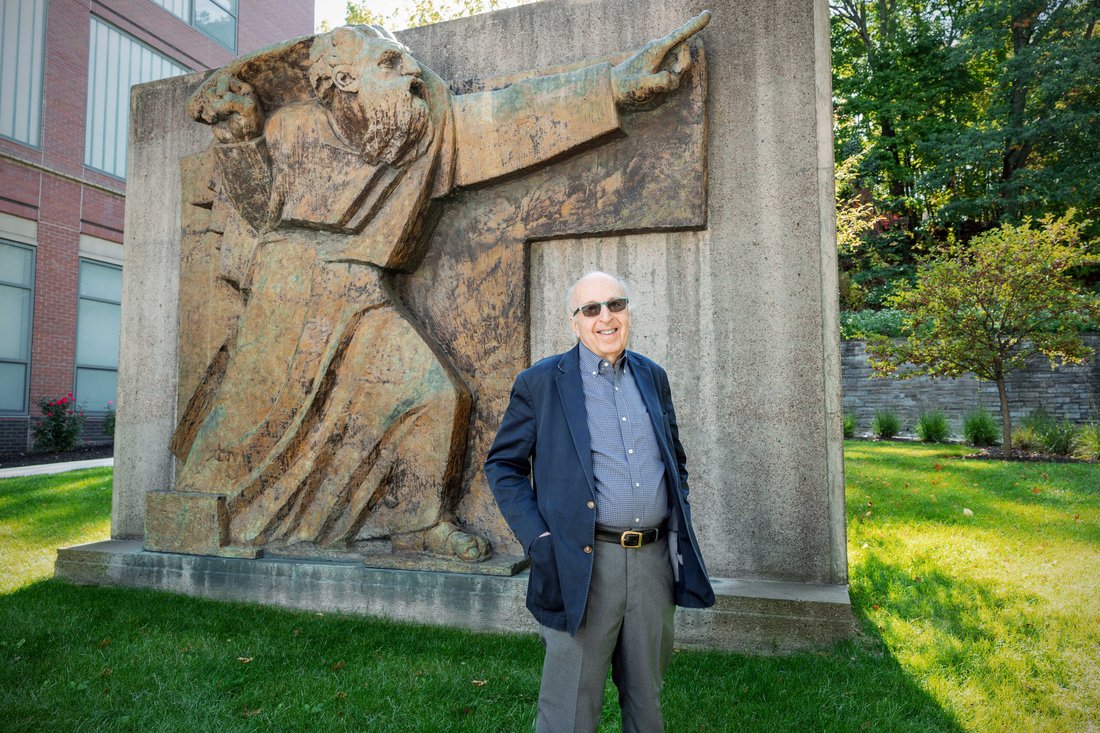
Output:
top-left (831, 0), bottom-right (1100, 242)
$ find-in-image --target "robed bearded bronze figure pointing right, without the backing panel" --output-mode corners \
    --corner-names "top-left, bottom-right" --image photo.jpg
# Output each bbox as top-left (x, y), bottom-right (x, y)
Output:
top-left (173, 13), bottom-right (710, 561)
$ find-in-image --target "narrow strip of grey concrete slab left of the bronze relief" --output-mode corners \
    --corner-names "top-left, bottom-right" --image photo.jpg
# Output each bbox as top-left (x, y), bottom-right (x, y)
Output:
top-left (111, 72), bottom-right (210, 539)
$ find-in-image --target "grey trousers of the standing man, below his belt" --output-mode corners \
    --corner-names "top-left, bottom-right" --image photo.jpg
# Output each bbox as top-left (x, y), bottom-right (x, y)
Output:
top-left (535, 530), bottom-right (675, 733)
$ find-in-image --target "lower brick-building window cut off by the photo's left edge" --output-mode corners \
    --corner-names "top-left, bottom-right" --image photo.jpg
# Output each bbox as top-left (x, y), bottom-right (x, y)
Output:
top-left (0, 241), bottom-right (34, 415)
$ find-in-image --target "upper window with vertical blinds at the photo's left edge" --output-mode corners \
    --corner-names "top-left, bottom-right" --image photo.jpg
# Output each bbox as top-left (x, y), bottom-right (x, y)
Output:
top-left (0, 0), bottom-right (46, 147)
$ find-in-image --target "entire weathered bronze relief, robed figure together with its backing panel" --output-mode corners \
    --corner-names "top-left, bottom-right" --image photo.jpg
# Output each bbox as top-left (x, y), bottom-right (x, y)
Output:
top-left (146, 13), bottom-right (710, 568)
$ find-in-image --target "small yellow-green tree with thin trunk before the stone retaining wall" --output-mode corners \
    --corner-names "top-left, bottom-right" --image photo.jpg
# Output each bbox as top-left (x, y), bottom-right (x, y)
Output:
top-left (867, 211), bottom-right (1100, 455)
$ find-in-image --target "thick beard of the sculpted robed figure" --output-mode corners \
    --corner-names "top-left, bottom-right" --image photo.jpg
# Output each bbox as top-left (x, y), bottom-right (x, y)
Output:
top-left (332, 79), bottom-right (429, 165)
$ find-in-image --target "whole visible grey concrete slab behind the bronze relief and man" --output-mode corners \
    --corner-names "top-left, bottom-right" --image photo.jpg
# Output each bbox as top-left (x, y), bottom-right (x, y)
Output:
top-left (112, 0), bottom-right (847, 583)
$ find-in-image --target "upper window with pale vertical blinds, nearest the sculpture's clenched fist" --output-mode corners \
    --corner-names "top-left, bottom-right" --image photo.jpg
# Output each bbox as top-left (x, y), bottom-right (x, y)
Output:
top-left (84, 18), bottom-right (189, 178)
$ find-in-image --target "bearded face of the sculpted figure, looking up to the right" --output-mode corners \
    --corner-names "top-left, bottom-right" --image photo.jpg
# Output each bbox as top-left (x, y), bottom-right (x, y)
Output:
top-left (332, 39), bottom-right (429, 165)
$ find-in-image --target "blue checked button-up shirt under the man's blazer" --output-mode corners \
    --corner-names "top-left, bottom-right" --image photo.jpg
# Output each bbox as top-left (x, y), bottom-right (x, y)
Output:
top-left (580, 343), bottom-right (669, 529)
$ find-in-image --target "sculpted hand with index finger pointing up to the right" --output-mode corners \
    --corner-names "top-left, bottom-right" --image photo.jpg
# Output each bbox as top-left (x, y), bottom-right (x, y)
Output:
top-left (612, 10), bottom-right (711, 109)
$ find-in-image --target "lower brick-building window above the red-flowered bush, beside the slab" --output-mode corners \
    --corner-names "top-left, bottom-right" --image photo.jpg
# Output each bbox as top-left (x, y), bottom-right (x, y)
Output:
top-left (74, 260), bottom-right (122, 413)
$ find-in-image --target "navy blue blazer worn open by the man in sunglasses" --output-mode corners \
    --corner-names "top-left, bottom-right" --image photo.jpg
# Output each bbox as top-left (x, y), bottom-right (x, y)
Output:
top-left (485, 344), bottom-right (714, 634)
